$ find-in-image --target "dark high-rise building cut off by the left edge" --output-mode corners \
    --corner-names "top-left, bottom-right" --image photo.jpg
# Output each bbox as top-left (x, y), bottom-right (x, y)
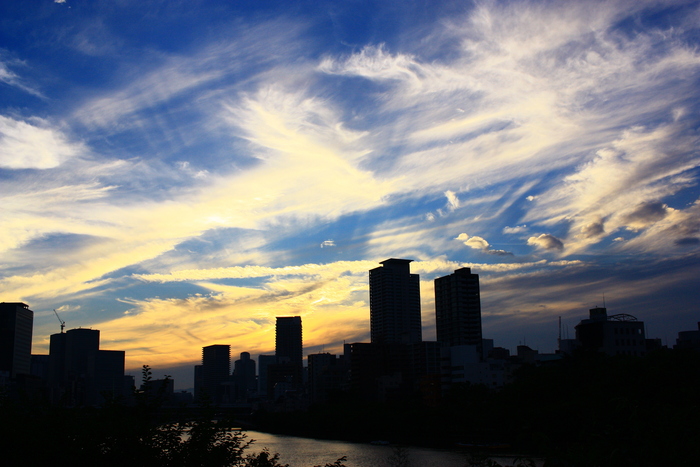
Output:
top-left (0, 302), bottom-right (34, 378)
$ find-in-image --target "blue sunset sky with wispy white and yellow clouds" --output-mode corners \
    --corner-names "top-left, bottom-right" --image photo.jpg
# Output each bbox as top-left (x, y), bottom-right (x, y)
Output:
top-left (0, 0), bottom-right (700, 387)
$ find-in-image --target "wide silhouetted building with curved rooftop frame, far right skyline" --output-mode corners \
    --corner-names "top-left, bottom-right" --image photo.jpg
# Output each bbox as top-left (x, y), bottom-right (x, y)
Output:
top-left (576, 307), bottom-right (646, 356)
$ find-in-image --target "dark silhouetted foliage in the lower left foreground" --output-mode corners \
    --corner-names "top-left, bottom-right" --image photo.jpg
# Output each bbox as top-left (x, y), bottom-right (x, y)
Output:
top-left (0, 366), bottom-right (345, 467)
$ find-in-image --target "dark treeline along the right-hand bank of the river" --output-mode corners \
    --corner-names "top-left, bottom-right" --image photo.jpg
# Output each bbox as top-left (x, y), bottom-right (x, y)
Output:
top-left (254, 349), bottom-right (700, 467)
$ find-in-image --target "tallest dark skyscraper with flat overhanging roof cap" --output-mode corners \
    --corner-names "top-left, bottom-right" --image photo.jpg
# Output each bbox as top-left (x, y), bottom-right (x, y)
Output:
top-left (369, 258), bottom-right (422, 344)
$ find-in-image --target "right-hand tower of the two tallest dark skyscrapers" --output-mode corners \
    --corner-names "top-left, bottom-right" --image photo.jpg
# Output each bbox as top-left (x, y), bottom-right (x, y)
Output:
top-left (435, 268), bottom-right (482, 353)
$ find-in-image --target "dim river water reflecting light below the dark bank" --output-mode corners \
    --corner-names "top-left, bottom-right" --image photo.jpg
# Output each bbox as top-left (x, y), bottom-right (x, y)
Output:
top-left (245, 431), bottom-right (532, 467)
